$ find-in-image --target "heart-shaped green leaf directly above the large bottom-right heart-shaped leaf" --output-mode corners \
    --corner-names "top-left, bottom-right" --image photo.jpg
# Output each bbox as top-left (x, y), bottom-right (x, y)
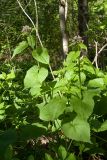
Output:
top-left (71, 91), bottom-right (94, 119)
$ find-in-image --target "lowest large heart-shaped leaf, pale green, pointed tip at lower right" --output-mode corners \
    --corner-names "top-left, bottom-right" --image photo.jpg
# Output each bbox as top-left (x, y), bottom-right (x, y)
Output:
top-left (62, 117), bottom-right (90, 142)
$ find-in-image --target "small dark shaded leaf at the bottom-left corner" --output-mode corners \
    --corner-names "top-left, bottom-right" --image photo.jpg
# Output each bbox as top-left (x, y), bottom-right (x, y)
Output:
top-left (4, 145), bottom-right (13, 160)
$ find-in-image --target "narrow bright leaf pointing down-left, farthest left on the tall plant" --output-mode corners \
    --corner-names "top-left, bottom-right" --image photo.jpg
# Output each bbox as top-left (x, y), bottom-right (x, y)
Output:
top-left (12, 41), bottom-right (28, 58)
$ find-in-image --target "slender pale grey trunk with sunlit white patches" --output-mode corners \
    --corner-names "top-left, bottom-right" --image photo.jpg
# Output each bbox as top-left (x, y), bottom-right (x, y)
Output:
top-left (59, 0), bottom-right (68, 58)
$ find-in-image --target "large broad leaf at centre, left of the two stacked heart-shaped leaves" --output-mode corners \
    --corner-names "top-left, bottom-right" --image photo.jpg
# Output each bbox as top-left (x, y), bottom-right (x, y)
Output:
top-left (39, 96), bottom-right (66, 121)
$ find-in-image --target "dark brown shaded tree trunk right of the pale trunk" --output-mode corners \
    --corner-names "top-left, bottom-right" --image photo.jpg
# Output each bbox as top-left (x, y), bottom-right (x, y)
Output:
top-left (78, 0), bottom-right (89, 47)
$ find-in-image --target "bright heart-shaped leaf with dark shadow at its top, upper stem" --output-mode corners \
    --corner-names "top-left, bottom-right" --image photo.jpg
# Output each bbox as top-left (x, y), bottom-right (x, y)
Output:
top-left (32, 48), bottom-right (49, 64)
